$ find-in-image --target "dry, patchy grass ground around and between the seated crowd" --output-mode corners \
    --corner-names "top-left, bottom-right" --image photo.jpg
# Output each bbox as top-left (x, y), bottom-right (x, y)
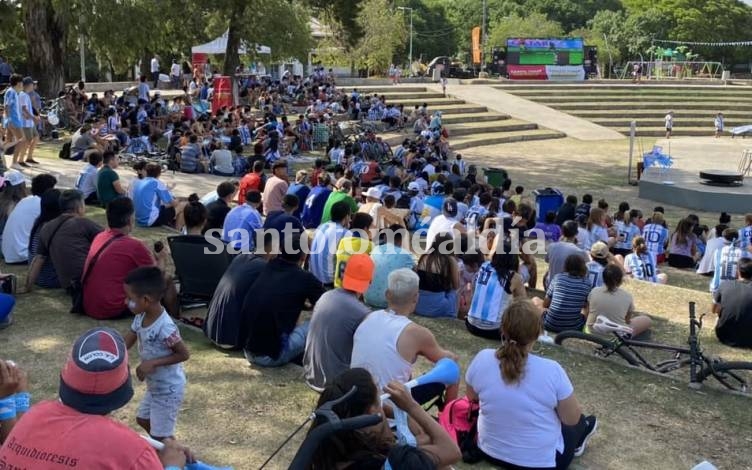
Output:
top-left (0, 139), bottom-right (752, 470)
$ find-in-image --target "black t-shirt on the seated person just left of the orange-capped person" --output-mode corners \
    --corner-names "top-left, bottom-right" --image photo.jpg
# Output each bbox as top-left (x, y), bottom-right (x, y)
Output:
top-left (243, 258), bottom-right (324, 359)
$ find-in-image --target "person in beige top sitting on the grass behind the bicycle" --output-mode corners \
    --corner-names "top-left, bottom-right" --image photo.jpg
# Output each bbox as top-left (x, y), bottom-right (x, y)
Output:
top-left (586, 264), bottom-right (653, 336)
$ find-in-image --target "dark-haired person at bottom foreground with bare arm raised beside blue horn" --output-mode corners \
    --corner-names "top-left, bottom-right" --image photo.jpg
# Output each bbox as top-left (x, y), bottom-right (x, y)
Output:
top-left (309, 368), bottom-right (461, 470)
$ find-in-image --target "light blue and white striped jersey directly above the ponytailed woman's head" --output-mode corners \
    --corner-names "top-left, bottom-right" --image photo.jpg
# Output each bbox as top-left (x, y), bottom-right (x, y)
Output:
top-left (467, 261), bottom-right (514, 330)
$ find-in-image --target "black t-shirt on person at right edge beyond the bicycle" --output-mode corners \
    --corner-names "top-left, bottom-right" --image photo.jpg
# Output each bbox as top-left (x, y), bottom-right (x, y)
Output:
top-left (714, 280), bottom-right (752, 348)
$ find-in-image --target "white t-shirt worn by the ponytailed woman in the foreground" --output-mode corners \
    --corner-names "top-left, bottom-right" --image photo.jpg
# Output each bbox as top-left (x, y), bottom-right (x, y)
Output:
top-left (465, 349), bottom-right (574, 468)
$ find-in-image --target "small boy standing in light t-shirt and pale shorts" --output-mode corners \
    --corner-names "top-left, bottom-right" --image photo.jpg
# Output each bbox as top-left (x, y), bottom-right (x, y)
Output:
top-left (125, 266), bottom-right (190, 440)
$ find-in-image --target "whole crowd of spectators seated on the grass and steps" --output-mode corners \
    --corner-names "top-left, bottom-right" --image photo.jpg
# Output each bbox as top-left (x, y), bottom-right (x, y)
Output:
top-left (0, 67), bottom-right (752, 469)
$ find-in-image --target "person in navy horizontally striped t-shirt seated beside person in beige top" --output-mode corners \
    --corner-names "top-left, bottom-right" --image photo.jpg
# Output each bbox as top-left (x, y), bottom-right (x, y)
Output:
top-left (533, 255), bottom-right (592, 333)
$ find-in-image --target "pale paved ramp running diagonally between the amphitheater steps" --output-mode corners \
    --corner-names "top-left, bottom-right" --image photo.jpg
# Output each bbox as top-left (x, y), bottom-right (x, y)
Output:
top-left (427, 84), bottom-right (625, 140)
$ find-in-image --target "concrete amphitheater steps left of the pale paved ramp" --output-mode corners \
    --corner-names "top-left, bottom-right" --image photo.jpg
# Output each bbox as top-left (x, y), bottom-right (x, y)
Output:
top-left (345, 86), bottom-right (564, 150)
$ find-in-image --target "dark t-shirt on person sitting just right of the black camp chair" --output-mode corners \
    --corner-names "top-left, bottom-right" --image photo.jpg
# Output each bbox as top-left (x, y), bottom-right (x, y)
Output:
top-left (204, 254), bottom-right (266, 348)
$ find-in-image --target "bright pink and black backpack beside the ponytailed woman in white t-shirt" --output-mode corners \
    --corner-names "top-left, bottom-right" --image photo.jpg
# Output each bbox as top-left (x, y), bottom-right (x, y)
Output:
top-left (439, 397), bottom-right (480, 463)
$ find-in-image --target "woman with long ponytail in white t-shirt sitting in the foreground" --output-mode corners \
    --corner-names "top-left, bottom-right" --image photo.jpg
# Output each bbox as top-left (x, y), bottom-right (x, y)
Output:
top-left (465, 299), bottom-right (598, 470)
